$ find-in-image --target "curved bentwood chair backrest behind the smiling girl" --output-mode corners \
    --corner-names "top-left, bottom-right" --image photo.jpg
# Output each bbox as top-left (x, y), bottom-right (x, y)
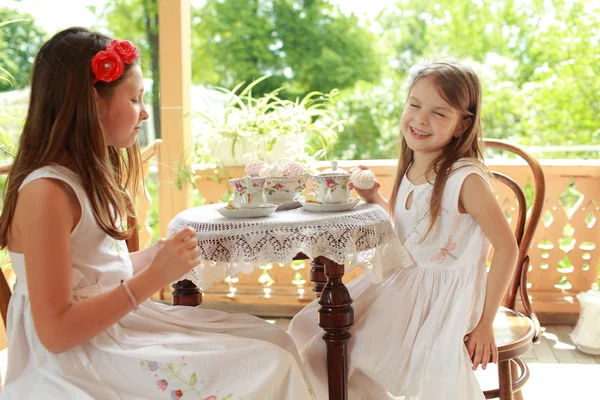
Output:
top-left (484, 139), bottom-right (546, 340)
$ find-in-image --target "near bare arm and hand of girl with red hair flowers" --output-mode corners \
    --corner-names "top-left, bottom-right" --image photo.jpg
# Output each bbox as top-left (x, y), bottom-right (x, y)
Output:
top-left (13, 179), bottom-right (198, 353)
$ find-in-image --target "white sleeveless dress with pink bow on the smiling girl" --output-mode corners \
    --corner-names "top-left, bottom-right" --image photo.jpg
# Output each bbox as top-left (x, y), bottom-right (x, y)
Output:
top-left (289, 163), bottom-right (489, 400)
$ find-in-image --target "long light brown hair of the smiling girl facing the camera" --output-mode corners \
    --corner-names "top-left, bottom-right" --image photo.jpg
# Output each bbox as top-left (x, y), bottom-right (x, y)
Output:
top-left (389, 61), bottom-right (487, 241)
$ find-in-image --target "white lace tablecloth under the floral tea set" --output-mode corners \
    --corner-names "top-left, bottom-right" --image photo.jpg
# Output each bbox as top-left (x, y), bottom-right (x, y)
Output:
top-left (169, 203), bottom-right (413, 290)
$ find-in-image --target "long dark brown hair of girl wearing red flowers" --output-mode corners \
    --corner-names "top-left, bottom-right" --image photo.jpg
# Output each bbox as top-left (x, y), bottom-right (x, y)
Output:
top-left (0, 27), bottom-right (141, 248)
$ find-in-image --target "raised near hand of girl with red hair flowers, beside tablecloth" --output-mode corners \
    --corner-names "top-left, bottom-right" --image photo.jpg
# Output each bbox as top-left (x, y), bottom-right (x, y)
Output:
top-left (148, 227), bottom-right (200, 284)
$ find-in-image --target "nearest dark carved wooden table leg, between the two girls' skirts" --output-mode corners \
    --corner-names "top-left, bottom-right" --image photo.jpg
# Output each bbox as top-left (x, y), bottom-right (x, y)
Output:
top-left (311, 257), bottom-right (354, 400)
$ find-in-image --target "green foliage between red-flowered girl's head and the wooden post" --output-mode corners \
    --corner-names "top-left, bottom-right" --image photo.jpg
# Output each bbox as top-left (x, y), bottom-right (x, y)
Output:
top-left (98, 0), bottom-right (160, 138)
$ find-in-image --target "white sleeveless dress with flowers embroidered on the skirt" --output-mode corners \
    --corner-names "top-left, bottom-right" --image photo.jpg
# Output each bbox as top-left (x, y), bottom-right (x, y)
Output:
top-left (0, 166), bottom-right (313, 400)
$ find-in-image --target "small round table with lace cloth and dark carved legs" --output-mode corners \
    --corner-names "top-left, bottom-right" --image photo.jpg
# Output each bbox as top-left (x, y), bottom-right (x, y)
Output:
top-left (169, 203), bottom-right (413, 400)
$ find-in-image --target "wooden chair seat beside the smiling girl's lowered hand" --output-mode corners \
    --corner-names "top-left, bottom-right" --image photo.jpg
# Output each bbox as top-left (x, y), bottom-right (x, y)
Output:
top-left (494, 307), bottom-right (535, 361)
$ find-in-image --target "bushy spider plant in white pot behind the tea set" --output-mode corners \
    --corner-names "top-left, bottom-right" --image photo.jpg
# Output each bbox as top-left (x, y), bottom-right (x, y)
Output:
top-left (193, 76), bottom-right (343, 166)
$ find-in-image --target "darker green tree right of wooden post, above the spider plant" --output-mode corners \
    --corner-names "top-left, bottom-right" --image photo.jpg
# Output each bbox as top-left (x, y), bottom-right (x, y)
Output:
top-left (192, 0), bottom-right (381, 97)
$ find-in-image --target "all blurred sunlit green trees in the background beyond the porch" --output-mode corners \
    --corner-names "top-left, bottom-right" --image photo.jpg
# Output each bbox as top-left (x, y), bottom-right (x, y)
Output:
top-left (0, 0), bottom-right (600, 166)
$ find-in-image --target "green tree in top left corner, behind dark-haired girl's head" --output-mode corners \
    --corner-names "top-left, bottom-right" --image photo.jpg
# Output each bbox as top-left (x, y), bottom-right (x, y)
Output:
top-left (0, 7), bottom-right (48, 92)
